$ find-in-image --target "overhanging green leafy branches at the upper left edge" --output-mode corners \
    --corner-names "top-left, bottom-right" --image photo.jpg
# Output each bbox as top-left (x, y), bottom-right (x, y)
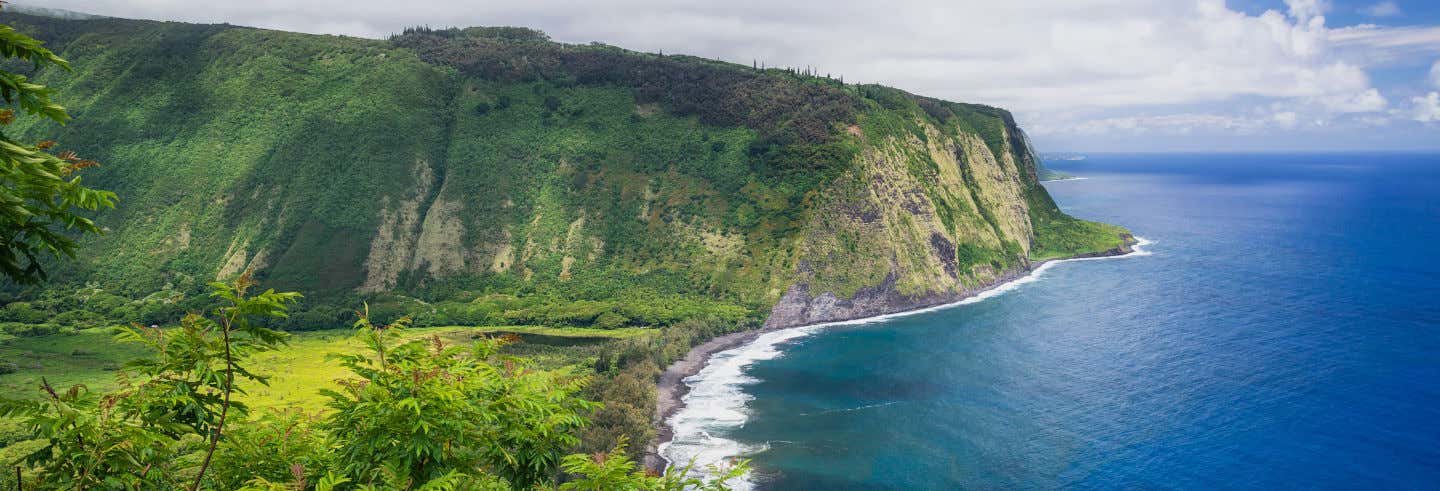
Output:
top-left (0, 18), bottom-right (115, 284)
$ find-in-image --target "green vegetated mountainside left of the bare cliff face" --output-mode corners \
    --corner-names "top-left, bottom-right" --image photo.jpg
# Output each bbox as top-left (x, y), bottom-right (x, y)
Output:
top-left (0, 16), bottom-right (855, 308)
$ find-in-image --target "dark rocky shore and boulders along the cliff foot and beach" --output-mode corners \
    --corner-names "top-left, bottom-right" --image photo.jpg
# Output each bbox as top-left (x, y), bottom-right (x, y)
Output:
top-left (644, 235), bottom-right (1136, 472)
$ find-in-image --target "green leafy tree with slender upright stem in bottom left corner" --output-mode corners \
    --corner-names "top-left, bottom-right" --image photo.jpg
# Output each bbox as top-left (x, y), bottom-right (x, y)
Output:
top-left (0, 274), bottom-right (300, 491)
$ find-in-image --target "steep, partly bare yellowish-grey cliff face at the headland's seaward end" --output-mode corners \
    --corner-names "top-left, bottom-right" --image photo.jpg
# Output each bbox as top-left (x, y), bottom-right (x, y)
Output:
top-left (766, 99), bottom-right (1129, 327)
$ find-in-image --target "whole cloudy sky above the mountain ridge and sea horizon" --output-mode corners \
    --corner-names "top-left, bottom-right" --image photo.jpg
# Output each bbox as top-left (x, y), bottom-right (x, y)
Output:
top-left (19, 0), bottom-right (1440, 151)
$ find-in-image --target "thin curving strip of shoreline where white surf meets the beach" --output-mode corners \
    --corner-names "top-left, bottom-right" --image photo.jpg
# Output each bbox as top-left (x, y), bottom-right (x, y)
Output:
top-left (642, 238), bottom-right (1149, 472)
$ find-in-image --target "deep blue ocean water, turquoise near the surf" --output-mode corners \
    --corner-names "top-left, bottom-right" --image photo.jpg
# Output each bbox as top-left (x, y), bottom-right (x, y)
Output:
top-left (726, 154), bottom-right (1440, 490)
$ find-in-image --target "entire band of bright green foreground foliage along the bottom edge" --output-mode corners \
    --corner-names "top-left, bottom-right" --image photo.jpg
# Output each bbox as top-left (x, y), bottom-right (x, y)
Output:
top-left (0, 275), bottom-right (744, 490)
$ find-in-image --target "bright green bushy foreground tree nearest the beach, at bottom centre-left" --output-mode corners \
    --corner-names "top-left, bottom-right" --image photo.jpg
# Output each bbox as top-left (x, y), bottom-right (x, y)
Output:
top-left (321, 310), bottom-right (596, 488)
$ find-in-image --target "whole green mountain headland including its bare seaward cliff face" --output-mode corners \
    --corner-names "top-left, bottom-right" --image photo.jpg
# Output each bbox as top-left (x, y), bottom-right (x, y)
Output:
top-left (0, 14), bottom-right (1128, 325)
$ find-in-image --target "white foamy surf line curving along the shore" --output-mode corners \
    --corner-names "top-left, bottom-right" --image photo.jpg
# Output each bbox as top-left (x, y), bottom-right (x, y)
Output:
top-left (657, 238), bottom-right (1153, 490)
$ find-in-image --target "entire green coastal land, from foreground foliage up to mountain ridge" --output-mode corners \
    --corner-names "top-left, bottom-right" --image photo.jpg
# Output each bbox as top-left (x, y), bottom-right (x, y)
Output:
top-left (0, 11), bottom-right (1126, 490)
